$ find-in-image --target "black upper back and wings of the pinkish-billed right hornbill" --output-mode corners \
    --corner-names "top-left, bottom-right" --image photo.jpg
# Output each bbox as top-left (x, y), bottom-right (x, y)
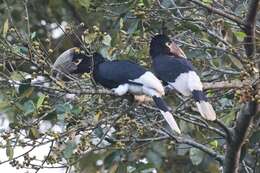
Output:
top-left (152, 55), bottom-right (194, 84)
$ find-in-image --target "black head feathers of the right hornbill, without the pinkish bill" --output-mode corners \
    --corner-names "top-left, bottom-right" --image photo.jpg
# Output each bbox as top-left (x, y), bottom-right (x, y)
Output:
top-left (150, 34), bottom-right (172, 58)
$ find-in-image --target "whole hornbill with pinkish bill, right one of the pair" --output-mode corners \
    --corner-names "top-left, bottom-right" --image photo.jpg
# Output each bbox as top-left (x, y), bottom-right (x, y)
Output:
top-left (150, 35), bottom-right (216, 121)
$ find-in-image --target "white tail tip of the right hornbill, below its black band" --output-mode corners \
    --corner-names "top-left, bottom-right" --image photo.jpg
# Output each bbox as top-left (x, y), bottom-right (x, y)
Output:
top-left (196, 101), bottom-right (216, 121)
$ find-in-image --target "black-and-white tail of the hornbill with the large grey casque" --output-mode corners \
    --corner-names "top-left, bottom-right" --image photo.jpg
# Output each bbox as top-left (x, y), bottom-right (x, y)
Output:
top-left (153, 96), bottom-right (181, 134)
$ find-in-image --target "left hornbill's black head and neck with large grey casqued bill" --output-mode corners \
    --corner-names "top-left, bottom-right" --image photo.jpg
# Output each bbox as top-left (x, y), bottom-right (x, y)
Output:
top-left (53, 47), bottom-right (105, 79)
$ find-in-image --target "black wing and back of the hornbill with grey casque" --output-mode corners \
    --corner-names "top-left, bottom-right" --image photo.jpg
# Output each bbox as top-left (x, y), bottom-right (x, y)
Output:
top-left (94, 60), bottom-right (146, 88)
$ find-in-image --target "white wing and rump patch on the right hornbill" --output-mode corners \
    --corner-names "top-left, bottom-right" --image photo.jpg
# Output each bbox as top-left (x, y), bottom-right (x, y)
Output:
top-left (169, 71), bottom-right (202, 96)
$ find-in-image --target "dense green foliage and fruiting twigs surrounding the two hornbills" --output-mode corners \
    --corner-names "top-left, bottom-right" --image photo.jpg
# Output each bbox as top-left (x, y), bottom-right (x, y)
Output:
top-left (0, 0), bottom-right (260, 173)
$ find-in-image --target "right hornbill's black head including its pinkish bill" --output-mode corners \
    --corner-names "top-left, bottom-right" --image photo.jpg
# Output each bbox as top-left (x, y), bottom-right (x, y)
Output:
top-left (150, 34), bottom-right (186, 58)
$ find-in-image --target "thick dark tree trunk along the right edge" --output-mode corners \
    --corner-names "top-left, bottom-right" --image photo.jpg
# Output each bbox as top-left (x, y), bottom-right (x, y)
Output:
top-left (223, 0), bottom-right (259, 173)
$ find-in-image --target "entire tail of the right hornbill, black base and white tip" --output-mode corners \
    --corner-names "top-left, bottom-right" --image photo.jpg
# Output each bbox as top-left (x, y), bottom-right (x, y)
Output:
top-left (192, 90), bottom-right (216, 121)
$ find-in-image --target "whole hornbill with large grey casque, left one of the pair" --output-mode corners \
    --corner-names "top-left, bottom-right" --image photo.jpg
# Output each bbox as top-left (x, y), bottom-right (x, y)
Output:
top-left (54, 48), bottom-right (181, 134)
